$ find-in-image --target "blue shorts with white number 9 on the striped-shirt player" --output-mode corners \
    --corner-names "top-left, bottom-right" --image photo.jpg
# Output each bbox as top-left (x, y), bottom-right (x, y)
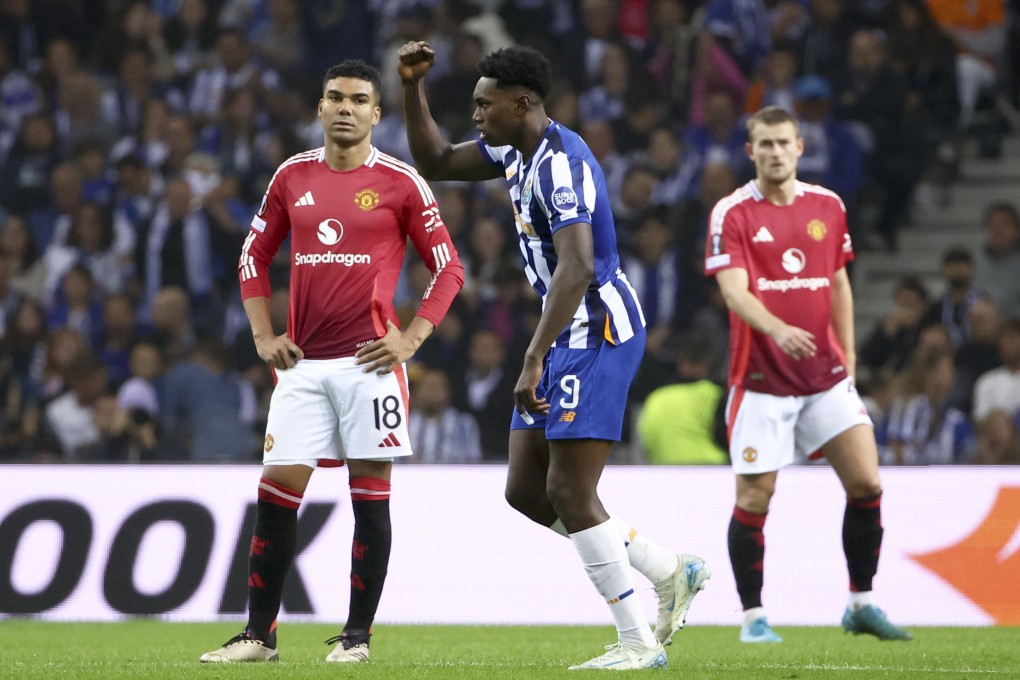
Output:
top-left (510, 328), bottom-right (646, 441)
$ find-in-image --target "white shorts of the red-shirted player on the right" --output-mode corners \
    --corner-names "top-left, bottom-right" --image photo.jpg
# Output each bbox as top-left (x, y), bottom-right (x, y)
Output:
top-left (726, 377), bottom-right (872, 474)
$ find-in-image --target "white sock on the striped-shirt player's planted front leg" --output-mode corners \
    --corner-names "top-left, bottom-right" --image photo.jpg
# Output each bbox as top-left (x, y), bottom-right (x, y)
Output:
top-left (570, 519), bottom-right (656, 647)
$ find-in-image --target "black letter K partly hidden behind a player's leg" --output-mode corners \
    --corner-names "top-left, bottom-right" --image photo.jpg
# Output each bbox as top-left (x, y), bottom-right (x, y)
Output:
top-left (219, 503), bottom-right (337, 614)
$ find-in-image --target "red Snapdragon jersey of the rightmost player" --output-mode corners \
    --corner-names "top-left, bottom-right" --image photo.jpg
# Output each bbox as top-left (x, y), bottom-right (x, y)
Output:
top-left (705, 180), bottom-right (854, 397)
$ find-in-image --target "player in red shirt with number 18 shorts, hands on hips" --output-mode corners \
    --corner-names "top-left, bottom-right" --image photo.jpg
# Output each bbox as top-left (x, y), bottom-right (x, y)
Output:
top-left (201, 60), bottom-right (464, 663)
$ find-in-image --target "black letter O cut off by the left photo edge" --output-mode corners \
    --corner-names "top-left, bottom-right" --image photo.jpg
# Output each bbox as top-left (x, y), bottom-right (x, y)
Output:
top-left (0, 501), bottom-right (92, 614)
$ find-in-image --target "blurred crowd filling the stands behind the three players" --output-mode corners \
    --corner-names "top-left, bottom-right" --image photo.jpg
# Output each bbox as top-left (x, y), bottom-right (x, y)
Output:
top-left (0, 0), bottom-right (1020, 465)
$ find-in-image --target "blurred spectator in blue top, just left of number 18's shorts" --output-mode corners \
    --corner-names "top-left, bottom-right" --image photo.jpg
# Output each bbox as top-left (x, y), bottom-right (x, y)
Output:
top-left (160, 339), bottom-right (259, 463)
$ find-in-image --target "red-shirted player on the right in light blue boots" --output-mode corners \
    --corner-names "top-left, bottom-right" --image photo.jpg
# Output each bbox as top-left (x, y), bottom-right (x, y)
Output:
top-left (705, 107), bottom-right (910, 642)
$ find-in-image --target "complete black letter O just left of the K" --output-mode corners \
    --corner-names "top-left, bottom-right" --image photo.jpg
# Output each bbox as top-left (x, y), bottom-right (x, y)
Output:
top-left (103, 501), bottom-right (214, 614)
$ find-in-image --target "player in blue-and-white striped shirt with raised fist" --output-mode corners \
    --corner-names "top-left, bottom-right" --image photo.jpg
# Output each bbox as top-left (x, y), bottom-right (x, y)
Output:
top-left (398, 42), bottom-right (709, 670)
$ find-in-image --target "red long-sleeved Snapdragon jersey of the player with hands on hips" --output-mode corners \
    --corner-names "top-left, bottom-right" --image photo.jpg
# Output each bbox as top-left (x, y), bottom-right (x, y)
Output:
top-left (238, 148), bottom-right (464, 359)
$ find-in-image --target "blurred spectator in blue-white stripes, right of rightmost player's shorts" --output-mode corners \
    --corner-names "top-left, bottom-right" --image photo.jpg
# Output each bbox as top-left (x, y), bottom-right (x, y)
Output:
top-left (882, 349), bottom-right (975, 465)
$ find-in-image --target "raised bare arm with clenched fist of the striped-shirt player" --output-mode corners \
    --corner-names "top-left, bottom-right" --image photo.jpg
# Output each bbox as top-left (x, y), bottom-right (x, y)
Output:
top-left (397, 41), bottom-right (501, 181)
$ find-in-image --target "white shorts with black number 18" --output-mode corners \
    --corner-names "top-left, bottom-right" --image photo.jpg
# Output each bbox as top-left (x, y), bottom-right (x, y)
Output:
top-left (262, 357), bottom-right (411, 467)
